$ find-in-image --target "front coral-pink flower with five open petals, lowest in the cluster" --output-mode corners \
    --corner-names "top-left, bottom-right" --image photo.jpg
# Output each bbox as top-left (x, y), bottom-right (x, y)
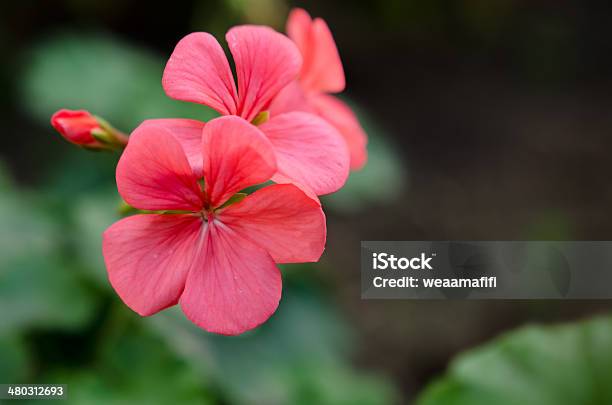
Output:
top-left (103, 117), bottom-right (326, 335)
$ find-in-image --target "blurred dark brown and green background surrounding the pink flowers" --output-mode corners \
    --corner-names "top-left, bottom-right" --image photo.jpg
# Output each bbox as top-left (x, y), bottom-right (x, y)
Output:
top-left (0, 0), bottom-right (612, 405)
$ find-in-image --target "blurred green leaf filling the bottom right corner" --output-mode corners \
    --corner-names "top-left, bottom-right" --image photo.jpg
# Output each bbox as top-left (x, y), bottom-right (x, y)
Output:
top-left (417, 317), bottom-right (612, 405)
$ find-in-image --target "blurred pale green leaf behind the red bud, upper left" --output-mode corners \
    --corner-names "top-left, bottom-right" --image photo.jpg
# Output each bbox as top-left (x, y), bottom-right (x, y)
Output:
top-left (20, 33), bottom-right (216, 132)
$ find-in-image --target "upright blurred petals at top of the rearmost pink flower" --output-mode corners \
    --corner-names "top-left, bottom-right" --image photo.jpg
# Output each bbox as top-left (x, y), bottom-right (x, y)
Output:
top-left (287, 8), bottom-right (345, 93)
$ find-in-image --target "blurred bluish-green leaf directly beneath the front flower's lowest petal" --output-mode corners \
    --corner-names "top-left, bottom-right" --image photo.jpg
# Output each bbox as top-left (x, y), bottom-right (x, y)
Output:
top-left (146, 287), bottom-right (396, 404)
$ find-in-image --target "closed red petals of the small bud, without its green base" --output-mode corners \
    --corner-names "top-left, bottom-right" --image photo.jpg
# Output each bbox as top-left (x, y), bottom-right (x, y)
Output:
top-left (51, 109), bottom-right (104, 148)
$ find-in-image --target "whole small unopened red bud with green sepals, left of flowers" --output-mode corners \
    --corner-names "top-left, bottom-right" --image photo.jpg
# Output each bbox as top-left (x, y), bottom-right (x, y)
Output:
top-left (51, 109), bottom-right (127, 149)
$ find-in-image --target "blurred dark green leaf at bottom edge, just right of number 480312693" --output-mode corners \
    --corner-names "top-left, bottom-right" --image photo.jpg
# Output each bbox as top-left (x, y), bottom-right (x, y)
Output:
top-left (41, 325), bottom-right (216, 405)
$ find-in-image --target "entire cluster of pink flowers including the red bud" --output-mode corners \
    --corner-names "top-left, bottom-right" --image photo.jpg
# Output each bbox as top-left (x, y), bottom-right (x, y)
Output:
top-left (52, 9), bottom-right (367, 335)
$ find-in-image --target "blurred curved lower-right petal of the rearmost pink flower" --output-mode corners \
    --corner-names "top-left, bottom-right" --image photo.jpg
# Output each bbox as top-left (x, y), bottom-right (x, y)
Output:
top-left (310, 94), bottom-right (368, 170)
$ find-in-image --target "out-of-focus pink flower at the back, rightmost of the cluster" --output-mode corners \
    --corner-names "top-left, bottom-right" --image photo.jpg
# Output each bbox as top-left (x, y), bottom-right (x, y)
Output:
top-left (270, 8), bottom-right (368, 170)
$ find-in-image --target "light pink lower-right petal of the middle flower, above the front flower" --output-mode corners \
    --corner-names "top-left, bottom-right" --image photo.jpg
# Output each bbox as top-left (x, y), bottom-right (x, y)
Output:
top-left (260, 112), bottom-right (349, 195)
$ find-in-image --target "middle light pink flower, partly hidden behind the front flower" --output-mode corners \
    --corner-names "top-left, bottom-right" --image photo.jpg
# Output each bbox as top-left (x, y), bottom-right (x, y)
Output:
top-left (162, 26), bottom-right (349, 195)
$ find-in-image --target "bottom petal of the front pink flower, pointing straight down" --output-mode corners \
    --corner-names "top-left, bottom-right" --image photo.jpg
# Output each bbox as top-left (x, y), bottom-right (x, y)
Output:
top-left (180, 221), bottom-right (282, 335)
